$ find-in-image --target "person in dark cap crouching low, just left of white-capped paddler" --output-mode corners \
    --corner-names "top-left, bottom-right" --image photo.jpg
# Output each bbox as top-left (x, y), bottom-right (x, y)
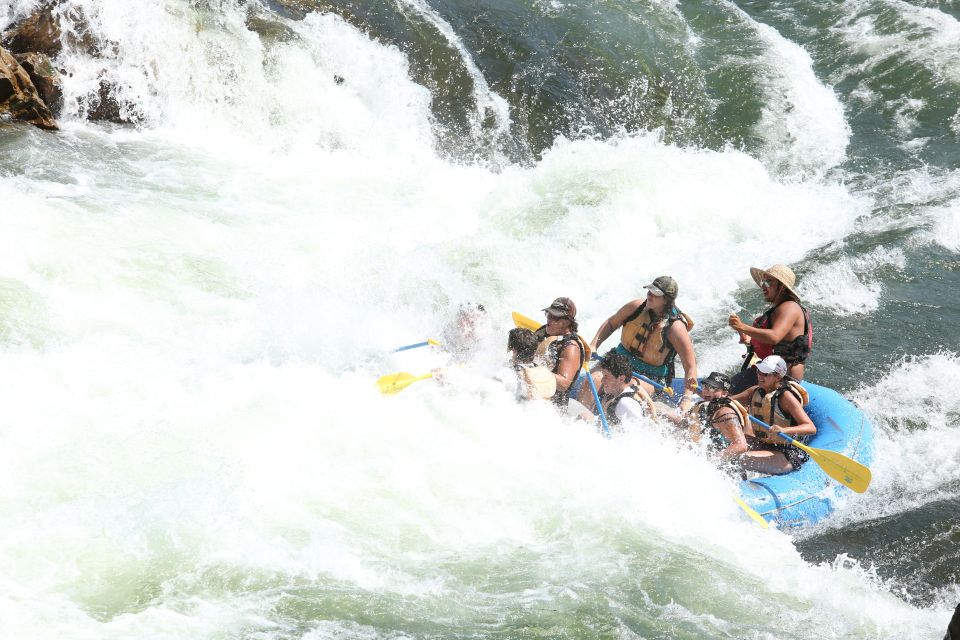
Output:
top-left (677, 371), bottom-right (753, 464)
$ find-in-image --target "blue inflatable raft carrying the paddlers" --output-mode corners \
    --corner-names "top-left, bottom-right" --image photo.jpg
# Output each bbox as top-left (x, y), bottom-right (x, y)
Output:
top-left (674, 379), bottom-right (873, 528)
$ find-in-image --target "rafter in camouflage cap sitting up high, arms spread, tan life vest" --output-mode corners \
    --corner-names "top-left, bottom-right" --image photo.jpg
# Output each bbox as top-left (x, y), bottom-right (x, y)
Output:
top-left (590, 276), bottom-right (697, 397)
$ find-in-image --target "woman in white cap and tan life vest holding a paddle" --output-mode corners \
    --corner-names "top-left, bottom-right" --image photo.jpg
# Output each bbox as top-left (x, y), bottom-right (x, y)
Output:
top-left (733, 356), bottom-right (817, 475)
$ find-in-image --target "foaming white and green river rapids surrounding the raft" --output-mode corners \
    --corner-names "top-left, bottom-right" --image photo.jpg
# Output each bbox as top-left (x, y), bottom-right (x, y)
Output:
top-left (0, 0), bottom-right (960, 640)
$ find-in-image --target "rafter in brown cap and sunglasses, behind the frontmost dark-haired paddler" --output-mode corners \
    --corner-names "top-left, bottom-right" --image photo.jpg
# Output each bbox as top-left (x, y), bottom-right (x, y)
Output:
top-left (534, 298), bottom-right (586, 407)
